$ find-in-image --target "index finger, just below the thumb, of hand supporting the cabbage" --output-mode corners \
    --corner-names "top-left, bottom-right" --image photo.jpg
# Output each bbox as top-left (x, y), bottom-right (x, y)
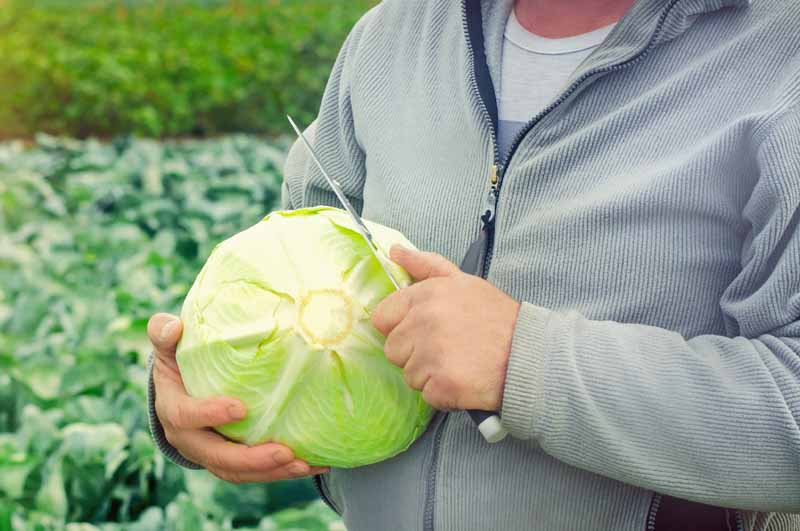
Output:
top-left (156, 378), bottom-right (247, 430)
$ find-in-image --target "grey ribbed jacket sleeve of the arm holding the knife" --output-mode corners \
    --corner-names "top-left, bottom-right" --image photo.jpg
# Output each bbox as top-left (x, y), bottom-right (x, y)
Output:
top-left (502, 108), bottom-right (800, 512)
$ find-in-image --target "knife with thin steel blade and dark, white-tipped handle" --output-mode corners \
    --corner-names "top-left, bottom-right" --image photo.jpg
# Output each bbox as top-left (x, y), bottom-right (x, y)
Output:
top-left (286, 115), bottom-right (508, 443)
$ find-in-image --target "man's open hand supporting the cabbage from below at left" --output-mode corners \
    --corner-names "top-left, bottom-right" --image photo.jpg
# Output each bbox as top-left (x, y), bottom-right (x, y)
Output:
top-left (147, 313), bottom-right (327, 483)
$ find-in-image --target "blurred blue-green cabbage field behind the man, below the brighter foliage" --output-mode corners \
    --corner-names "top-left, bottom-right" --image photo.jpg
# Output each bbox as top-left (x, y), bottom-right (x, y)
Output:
top-left (0, 136), bottom-right (344, 531)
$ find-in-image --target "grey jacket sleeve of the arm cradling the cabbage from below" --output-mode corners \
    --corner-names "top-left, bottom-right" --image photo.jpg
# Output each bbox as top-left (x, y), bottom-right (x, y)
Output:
top-left (147, 6), bottom-right (379, 469)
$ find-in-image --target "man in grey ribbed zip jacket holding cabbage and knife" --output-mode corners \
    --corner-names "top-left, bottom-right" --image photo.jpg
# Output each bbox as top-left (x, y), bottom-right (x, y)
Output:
top-left (150, 0), bottom-right (800, 531)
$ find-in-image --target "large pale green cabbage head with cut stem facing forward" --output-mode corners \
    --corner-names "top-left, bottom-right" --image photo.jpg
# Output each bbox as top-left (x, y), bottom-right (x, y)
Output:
top-left (177, 207), bottom-right (432, 468)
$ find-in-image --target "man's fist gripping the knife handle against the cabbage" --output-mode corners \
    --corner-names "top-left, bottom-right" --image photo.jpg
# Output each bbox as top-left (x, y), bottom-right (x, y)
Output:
top-left (372, 245), bottom-right (520, 411)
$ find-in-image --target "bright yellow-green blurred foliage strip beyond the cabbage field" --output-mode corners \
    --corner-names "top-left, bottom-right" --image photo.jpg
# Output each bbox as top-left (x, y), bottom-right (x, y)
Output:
top-left (0, 0), bottom-right (375, 138)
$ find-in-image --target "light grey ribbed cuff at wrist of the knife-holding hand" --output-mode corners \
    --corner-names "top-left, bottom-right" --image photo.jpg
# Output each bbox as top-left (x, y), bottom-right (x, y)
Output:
top-left (500, 302), bottom-right (555, 440)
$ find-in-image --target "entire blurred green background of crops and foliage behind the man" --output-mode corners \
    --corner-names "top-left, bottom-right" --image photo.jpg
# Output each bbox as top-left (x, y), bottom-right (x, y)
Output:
top-left (0, 0), bottom-right (375, 531)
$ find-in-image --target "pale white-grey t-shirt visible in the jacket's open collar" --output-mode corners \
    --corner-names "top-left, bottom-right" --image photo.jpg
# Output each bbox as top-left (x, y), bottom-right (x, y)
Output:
top-left (497, 10), bottom-right (614, 157)
